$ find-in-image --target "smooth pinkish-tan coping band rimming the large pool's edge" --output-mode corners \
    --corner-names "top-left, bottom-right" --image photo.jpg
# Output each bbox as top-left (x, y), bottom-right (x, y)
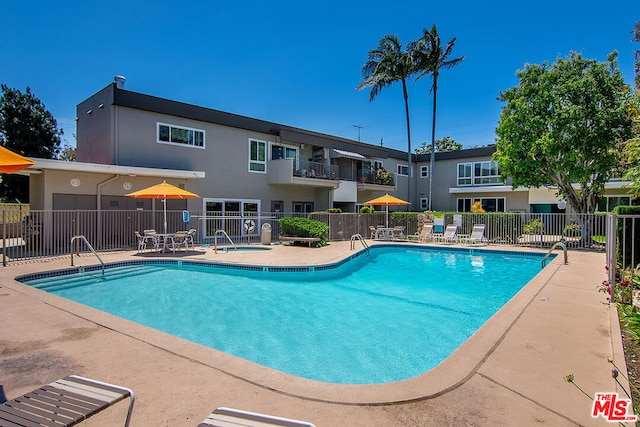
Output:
top-left (8, 245), bottom-right (562, 405)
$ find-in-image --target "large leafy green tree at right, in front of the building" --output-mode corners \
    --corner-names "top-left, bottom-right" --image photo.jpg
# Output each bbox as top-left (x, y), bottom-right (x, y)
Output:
top-left (493, 52), bottom-right (633, 212)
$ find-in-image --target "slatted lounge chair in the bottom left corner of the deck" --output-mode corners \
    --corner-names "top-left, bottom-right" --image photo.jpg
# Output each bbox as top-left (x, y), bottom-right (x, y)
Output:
top-left (0, 375), bottom-right (135, 427)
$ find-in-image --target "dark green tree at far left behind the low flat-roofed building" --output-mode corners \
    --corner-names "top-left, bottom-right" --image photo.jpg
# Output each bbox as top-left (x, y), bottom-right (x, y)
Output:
top-left (0, 84), bottom-right (63, 201)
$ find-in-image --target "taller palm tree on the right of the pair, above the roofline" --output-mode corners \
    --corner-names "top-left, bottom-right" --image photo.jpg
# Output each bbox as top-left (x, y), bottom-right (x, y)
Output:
top-left (407, 24), bottom-right (464, 210)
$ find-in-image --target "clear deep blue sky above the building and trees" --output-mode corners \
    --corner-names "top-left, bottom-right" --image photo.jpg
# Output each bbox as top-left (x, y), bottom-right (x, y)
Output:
top-left (0, 0), bottom-right (640, 151)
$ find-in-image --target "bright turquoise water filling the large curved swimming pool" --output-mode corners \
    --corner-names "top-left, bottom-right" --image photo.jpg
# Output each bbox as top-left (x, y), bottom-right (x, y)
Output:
top-left (22, 246), bottom-right (541, 384)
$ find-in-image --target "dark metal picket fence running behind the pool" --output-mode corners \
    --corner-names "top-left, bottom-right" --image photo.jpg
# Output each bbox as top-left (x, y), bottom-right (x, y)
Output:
top-left (0, 211), bottom-right (640, 265)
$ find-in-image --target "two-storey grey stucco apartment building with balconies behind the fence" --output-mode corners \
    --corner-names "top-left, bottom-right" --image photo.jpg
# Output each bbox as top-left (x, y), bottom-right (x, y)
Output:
top-left (30, 78), bottom-right (631, 222)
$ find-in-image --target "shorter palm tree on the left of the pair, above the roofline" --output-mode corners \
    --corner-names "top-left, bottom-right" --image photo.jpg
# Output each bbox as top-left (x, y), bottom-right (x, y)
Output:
top-left (356, 34), bottom-right (415, 208)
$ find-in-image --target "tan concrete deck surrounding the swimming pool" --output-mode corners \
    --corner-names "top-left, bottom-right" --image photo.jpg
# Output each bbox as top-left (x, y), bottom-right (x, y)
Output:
top-left (0, 242), bottom-right (626, 427)
